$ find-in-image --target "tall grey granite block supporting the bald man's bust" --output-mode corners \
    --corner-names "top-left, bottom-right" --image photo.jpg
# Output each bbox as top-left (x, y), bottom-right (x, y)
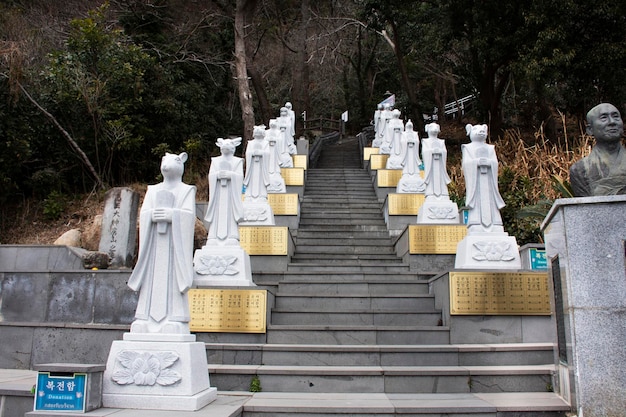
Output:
top-left (542, 195), bottom-right (626, 417)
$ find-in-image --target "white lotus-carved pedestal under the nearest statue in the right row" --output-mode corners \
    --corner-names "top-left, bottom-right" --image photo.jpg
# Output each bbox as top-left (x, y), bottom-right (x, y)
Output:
top-left (454, 231), bottom-right (522, 271)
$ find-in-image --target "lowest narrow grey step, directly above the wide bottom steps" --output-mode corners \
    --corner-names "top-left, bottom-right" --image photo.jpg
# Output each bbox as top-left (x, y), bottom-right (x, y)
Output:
top-left (267, 324), bottom-right (450, 345)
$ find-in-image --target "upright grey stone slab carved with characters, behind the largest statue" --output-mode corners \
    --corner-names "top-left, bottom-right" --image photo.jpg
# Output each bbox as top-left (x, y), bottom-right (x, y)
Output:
top-left (99, 187), bottom-right (139, 268)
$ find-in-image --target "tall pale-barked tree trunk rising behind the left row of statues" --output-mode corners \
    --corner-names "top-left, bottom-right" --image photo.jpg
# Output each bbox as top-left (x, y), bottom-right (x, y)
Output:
top-left (235, 0), bottom-right (256, 141)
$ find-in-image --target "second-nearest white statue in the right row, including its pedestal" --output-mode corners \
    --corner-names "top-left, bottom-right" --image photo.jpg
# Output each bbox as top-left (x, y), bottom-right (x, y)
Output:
top-left (417, 123), bottom-right (459, 224)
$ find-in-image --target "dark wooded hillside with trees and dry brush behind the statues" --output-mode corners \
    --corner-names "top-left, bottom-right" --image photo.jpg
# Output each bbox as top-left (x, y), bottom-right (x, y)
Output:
top-left (0, 0), bottom-right (626, 243)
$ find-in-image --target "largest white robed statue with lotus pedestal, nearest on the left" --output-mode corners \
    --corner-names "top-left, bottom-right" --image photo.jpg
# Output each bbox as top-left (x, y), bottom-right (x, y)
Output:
top-left (102, 153), bottom-right (217, 411)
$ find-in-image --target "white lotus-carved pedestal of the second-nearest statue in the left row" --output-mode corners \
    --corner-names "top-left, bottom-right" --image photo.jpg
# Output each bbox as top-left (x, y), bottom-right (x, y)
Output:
top-left (193, 241), bottom-right (256, 287)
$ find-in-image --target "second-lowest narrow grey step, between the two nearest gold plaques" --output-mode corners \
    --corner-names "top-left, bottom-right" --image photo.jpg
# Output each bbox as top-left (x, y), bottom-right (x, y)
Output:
top-left (272, 308), bottom-right (441, 326)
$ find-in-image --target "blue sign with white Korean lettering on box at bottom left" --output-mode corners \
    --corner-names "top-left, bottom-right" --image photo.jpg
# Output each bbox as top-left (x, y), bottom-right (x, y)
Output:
top-left (35, 372), bottom-right (87, 413)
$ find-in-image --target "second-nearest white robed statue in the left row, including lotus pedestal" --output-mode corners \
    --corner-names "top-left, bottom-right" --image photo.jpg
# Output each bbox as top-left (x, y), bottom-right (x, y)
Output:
top-left (193, 138), bottom-right (255, 287)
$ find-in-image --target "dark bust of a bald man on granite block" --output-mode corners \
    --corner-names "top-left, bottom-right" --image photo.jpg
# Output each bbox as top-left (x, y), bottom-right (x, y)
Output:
top-left (570, 103), bottom-right (626, 197)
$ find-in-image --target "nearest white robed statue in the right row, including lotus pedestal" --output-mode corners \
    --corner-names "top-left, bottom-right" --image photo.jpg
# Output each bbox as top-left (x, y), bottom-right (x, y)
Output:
top-left (454, 125), bottom-right (522, 270)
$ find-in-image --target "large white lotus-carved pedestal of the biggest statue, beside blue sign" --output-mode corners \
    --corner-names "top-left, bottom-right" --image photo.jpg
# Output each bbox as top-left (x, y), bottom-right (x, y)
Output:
top-left (102, 333), bottom-right (217, 411)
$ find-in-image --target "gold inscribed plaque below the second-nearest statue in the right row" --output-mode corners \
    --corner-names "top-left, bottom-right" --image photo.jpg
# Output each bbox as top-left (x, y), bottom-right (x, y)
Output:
top-left (409, 224), bottom-right (467, 255)
